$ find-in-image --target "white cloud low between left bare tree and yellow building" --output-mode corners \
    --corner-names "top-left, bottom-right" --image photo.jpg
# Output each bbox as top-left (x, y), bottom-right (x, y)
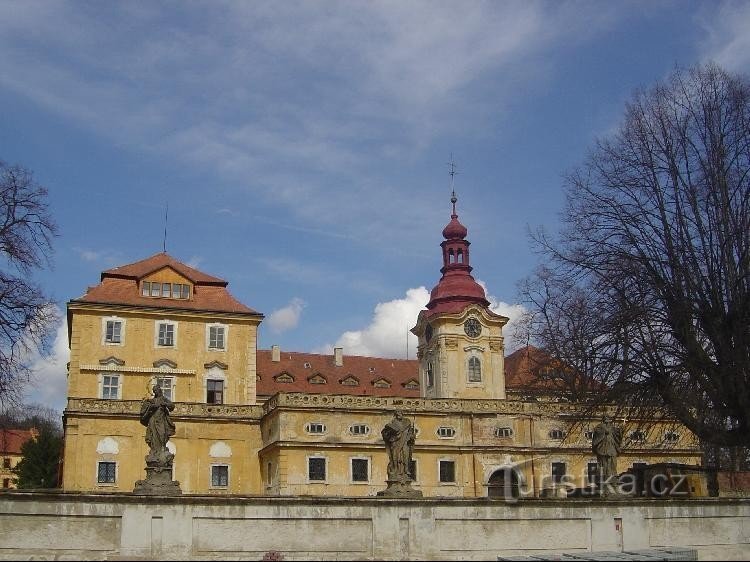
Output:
top-left (25, 310), bottom-right (70, 412)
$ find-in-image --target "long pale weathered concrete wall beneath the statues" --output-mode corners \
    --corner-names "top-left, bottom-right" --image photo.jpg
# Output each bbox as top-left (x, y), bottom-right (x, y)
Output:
top-left (0, 491), bottom-right (750, 560)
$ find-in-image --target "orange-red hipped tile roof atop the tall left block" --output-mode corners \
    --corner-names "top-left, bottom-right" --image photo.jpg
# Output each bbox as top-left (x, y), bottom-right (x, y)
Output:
top-left (71, 253), bottom-right (259, 315)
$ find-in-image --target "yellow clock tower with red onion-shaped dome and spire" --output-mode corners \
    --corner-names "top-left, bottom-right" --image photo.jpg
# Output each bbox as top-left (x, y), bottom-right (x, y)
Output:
top-left (411, 192), bottom-right (508, 399)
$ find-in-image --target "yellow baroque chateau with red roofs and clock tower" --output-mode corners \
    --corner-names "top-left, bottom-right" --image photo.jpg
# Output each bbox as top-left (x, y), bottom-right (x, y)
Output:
top-left (63, 197), bottom-right (700, 497)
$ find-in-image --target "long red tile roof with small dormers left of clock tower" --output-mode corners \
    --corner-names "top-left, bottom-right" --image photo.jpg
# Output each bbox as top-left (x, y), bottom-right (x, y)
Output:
top-left (257, 349), bottom-right (419, 398)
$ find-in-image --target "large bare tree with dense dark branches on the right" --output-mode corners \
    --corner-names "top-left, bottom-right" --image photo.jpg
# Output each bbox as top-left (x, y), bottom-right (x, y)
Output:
top-left (521, 65), bottom-right (750, 446)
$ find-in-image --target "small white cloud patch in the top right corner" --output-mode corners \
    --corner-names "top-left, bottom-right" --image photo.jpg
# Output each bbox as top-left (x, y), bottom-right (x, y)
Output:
top-left (700, 1), bottom-right (750, 72)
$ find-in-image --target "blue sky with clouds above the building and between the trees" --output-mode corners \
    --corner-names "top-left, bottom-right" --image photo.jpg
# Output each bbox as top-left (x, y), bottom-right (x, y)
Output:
top-left (0, 0), bottom-right (750, 407)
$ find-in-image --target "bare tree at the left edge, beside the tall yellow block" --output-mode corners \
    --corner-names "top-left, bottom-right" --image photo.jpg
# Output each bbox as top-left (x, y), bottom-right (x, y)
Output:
top-left (0, 161), bottom-right (57, 407)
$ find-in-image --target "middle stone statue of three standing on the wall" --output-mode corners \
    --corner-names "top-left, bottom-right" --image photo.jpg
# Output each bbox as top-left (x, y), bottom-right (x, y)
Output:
top-left (378, 411), bottom-right (422, 497)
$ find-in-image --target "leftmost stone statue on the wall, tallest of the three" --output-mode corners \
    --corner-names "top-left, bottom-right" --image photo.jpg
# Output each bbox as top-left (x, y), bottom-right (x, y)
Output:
top-left (133, 384), bottom-right (182, 495)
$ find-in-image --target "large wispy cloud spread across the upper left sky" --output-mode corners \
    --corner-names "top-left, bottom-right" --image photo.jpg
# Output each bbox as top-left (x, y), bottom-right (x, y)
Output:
top-left (0, 1), bottom-right (628, 245)
